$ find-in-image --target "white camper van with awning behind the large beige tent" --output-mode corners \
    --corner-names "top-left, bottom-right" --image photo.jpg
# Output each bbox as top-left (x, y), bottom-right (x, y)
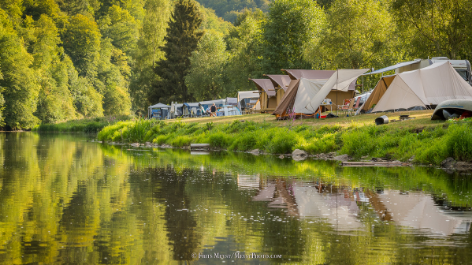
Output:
top-left (395, 57), bottom-right (472, 86)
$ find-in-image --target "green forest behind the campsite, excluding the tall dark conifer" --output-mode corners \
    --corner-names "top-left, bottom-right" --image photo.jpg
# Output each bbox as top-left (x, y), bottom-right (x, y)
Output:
top-left (0, 0), bottom-right (472, 129)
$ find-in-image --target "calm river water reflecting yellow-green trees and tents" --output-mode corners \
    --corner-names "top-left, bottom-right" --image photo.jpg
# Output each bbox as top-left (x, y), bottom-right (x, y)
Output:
top-left (0, 133), bottom-right (472, 264)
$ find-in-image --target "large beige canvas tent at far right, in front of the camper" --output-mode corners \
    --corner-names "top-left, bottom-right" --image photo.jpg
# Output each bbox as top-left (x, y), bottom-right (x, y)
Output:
top-left (372, 62), bottom-right (472, 112)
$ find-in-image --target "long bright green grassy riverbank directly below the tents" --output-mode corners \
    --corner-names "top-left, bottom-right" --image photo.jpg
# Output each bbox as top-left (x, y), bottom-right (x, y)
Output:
top-left (98, 111), bottom-right (472, 165)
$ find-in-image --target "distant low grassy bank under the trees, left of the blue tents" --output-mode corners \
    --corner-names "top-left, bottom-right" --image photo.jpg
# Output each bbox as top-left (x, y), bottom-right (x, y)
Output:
top-left (32, 115), bottom-right (131, 133)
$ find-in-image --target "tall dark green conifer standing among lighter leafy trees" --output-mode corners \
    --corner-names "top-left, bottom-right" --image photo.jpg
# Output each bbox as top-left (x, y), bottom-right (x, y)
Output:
top-left (149, 0), bottom-right (203, 103)
